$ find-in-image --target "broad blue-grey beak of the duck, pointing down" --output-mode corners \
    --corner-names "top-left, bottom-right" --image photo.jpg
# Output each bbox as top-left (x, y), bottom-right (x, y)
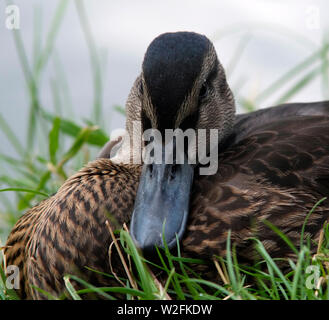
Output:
top-left (130, 145), bottom-right (194, 252)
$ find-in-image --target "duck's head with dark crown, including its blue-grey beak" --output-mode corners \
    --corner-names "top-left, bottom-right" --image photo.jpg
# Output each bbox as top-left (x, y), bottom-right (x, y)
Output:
top-left (127, 32), bottom-right (235, 251)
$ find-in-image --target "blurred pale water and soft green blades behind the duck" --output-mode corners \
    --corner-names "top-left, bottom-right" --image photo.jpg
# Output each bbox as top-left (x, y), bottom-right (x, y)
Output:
top-left (0, 0), bottom-right (329, 242)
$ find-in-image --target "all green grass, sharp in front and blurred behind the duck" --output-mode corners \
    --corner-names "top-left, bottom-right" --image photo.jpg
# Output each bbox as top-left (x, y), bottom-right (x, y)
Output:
top-left (0, 0), bottom-right (329, 300)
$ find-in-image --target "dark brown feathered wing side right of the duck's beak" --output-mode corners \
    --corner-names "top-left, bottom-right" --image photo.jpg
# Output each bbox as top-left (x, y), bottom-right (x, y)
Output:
top-left (183, 115), bottom-right (329, 259)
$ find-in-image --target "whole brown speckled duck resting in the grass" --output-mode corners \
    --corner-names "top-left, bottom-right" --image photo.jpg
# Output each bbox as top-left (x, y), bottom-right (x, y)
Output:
top-left (4, 31), bottom-right (329, 299)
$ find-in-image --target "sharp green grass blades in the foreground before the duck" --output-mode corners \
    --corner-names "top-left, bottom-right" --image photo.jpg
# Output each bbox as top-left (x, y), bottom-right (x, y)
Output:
top-left (0, 219), bottom-right (329, 300)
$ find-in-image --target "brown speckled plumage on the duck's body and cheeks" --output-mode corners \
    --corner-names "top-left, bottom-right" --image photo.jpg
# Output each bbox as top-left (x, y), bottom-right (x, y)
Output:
top-left (5, 31), bottom-right (329, 299)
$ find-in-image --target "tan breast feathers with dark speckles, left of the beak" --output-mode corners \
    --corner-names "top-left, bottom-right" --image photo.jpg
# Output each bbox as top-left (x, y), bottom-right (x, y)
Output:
top-left (5, 159), bottom-right (140, 299)
